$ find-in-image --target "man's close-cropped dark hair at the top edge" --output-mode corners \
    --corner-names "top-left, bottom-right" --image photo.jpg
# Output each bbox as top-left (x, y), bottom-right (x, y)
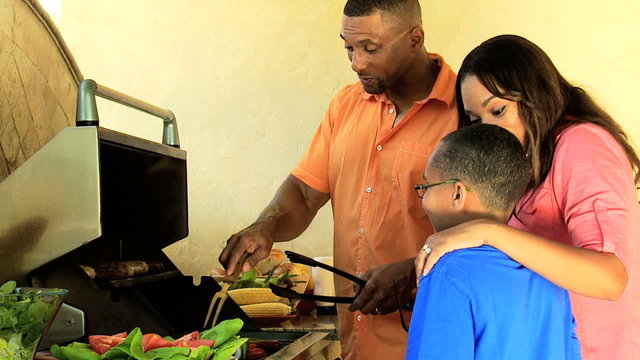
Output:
top-left (343, 0), bottom-right (422, 25)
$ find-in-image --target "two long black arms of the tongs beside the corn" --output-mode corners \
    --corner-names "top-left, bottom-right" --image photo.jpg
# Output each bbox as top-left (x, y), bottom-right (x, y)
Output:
top-left (269, 251), bottom-right (367, 304)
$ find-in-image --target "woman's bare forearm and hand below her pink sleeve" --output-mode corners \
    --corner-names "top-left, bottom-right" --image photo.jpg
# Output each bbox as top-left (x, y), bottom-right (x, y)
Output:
top-left (415, 220), bottom-right (628, 300)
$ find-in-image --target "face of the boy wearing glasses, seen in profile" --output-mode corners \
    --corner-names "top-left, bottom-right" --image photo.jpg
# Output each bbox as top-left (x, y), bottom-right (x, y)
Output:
top-left (422, 162), bottom-right (460, 232)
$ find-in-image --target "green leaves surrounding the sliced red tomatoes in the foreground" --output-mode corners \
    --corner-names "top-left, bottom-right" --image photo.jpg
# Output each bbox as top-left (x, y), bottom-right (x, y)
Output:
top-left (50, 319), bottom-right (248, 360)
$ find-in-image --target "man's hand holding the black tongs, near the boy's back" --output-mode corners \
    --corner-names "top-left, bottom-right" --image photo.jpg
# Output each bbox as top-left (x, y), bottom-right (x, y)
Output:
top-left (349, 258), bottom-right (416, 315)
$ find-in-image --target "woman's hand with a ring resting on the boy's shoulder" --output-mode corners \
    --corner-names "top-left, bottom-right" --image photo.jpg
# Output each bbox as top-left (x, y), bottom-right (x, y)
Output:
top-left (414, 219), bottom-right (496, 284)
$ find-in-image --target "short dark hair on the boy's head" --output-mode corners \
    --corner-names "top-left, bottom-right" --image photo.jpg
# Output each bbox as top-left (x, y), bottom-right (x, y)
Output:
top-left (430, 124), bottom-right (531, 212)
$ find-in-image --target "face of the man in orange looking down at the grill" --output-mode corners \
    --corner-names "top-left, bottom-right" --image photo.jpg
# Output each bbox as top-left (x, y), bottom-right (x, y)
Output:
top-left (340, 11), bottom-right (411, 94)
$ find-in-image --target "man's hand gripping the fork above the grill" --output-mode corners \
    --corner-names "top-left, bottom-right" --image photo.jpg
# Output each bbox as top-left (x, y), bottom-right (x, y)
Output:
top-left (218, 223), bottom-right (273, 275)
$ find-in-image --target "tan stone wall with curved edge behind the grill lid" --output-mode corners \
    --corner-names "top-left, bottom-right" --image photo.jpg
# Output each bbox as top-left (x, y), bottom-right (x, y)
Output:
top-left (0, 0), bottom-right (82, 181)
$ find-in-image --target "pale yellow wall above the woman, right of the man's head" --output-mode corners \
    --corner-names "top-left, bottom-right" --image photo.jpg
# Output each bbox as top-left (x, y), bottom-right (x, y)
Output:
top-left (421, 0), bottom-right (640, 144)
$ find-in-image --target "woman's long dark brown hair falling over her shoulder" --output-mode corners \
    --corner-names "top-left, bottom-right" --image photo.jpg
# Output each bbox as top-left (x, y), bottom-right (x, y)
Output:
top-left (456, 35), bottom-right (640, 188)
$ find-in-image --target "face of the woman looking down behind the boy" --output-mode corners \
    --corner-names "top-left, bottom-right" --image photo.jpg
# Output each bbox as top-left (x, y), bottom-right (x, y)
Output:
top-left (460, 75), bottom-right (527, 146)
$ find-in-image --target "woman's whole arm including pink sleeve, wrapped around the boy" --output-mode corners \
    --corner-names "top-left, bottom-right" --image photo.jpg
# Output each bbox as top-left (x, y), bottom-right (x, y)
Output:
top-left (416, 124), bottom-right (639, 300)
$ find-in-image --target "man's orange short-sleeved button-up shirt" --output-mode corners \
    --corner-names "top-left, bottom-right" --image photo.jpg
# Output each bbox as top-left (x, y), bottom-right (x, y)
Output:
top-left (292, 54), bottom-right (458, 360)
